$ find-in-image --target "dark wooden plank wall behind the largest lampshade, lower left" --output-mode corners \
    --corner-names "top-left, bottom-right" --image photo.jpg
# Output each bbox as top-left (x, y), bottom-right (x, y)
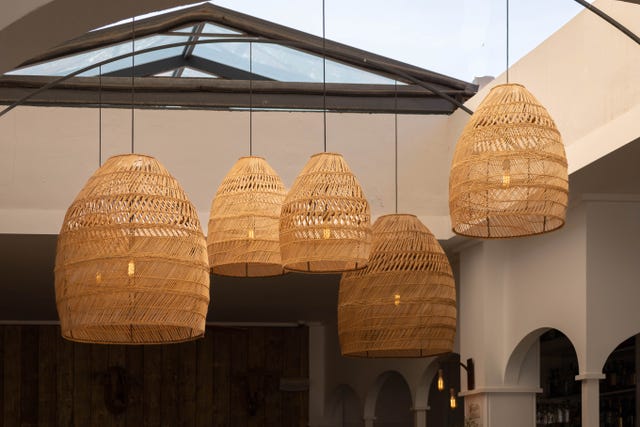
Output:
top-left (0, 325), bottom-right (308, 427)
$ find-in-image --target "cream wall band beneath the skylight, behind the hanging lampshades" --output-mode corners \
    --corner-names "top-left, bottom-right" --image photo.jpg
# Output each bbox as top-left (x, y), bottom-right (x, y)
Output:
top-left (0, 107), bottom-right (451, 238)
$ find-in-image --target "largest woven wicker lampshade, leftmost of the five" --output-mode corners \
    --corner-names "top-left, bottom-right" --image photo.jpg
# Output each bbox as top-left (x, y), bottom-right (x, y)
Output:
top-left (55, 154), bottom-right (209, 344)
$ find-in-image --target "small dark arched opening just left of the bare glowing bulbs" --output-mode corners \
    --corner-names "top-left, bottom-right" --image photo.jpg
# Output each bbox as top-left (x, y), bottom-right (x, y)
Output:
top-left (373, 372), bottom-right (413, 427)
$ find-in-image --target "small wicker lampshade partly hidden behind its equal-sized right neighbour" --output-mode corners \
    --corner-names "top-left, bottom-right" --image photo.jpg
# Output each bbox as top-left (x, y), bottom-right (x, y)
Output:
top-left (207, 156), bottom-right (286, 277)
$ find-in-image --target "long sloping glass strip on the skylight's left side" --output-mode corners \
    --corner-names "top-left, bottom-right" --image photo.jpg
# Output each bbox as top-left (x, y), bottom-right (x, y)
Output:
top-left (7, 35), bottom-right (188, 76)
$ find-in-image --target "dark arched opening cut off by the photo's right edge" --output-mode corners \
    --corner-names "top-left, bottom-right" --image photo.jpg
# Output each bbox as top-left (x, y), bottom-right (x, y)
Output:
top-left (600, 335), bottom-right (640, 427)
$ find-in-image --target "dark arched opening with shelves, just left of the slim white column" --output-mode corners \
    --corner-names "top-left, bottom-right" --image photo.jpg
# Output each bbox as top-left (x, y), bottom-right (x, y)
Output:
top-left (536, 329), bottom-right (581, 427)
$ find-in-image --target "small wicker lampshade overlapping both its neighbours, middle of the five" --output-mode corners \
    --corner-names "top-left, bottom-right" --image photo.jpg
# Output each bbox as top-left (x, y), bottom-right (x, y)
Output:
top-left (280, 153), bottom-right (371, 273)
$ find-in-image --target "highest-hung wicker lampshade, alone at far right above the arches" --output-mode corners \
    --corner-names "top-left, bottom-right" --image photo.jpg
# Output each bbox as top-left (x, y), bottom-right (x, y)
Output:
top-left (449, 84), bottom-right (569, 238)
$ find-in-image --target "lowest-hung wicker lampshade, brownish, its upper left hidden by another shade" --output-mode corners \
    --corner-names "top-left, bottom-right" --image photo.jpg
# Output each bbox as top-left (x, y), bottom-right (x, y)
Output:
top-left (338, 214), bottom-right (456, 357)
